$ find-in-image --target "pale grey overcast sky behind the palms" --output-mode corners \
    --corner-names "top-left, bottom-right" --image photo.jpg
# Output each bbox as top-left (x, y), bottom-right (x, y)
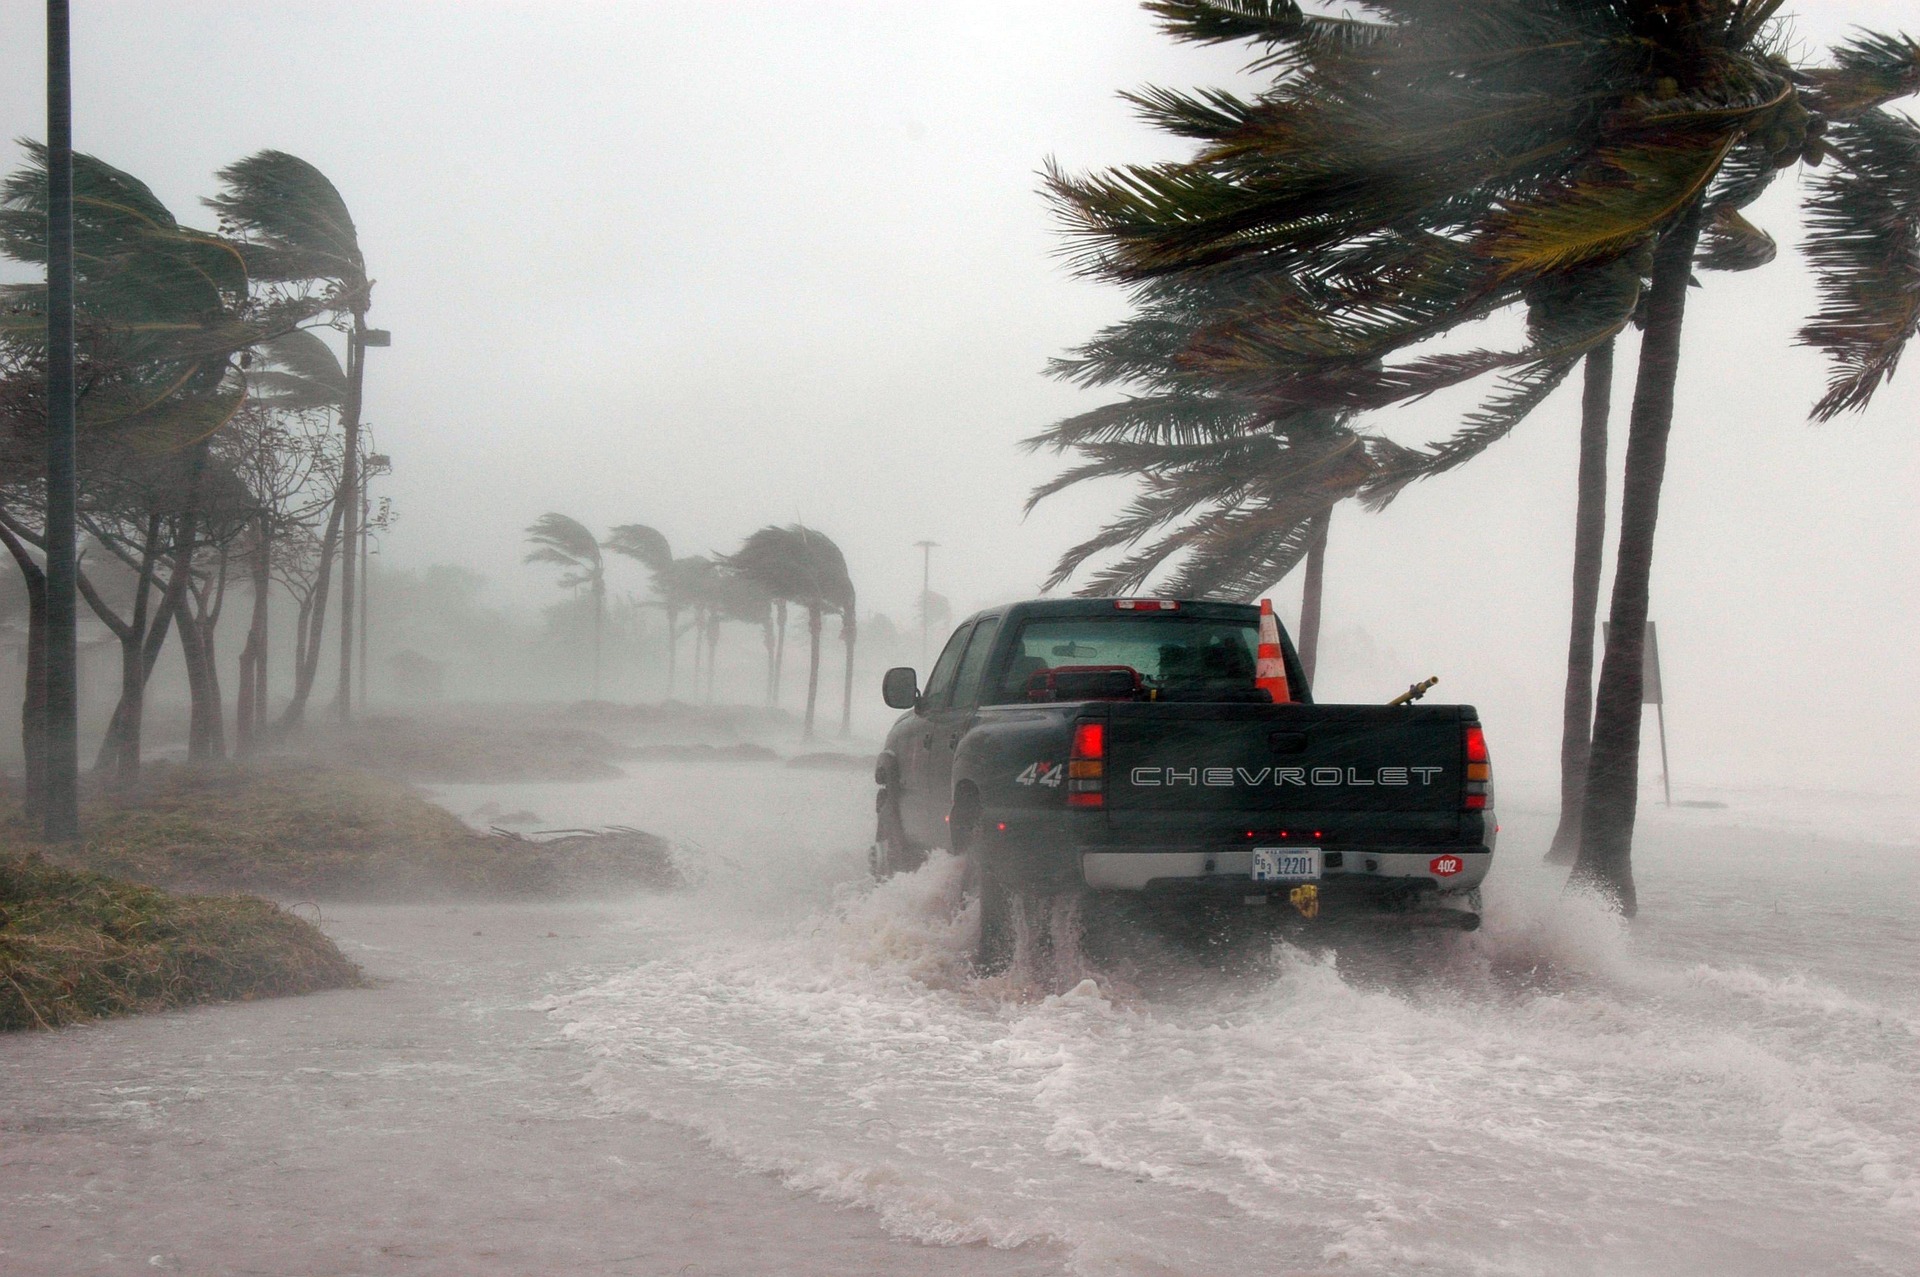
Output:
top-left (0, 0), bottom-right (1920, 791)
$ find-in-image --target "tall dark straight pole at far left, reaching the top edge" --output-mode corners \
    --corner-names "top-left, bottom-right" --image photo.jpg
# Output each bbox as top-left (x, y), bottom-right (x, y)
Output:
top-left (42, 0), bottom-right (81, 841)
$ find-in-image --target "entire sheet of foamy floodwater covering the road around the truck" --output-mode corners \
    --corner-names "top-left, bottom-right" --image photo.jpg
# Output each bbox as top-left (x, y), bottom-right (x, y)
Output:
top-left (0, 764), bottom-right (1920, 1277)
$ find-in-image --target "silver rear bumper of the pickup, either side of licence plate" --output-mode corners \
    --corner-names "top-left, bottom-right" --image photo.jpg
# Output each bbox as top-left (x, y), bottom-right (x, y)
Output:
top-left (1079, 845), bottom-right (1494, 895)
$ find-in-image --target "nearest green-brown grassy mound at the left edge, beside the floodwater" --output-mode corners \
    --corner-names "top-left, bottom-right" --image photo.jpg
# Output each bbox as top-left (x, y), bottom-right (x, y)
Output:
top-left (0, 853), bottom-right (365, 1029)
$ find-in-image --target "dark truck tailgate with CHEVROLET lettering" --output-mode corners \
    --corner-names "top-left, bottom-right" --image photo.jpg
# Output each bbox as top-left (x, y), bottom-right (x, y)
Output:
top-left (1106, 701), bottom-right (1473, 825)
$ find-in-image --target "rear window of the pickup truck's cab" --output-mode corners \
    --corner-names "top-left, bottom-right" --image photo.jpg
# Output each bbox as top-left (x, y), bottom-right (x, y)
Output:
top-left (987, 614), bottom-right (1260, 703)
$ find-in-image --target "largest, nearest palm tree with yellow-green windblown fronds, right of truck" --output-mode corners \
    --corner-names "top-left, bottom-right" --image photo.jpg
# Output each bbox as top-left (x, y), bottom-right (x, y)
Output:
top-left (1052, 0), bottom-right (1920, 912)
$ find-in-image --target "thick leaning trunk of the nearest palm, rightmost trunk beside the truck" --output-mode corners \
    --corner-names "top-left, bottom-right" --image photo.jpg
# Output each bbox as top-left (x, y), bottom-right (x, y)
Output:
top-left (1572, 207), bottom-right (1701, 918)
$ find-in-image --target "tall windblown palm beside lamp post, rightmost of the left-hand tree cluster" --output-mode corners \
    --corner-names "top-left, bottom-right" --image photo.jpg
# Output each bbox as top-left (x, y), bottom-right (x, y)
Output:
top-left (205, 150), bottom-right (372, 720)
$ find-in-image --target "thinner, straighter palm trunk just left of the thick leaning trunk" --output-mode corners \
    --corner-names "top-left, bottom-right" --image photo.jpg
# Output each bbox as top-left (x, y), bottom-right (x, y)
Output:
top-left (1548, 338), bottom-right (1613, 864)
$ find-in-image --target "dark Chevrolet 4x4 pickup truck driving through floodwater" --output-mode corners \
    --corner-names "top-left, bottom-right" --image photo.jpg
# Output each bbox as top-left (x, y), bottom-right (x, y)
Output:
top-left (872, 599), bottom-right (1498, 968)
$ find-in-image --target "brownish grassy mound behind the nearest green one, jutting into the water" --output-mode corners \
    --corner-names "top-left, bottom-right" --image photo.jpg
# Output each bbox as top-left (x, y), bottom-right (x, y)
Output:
top-left (0, 760), bottom-right (678, 901)
